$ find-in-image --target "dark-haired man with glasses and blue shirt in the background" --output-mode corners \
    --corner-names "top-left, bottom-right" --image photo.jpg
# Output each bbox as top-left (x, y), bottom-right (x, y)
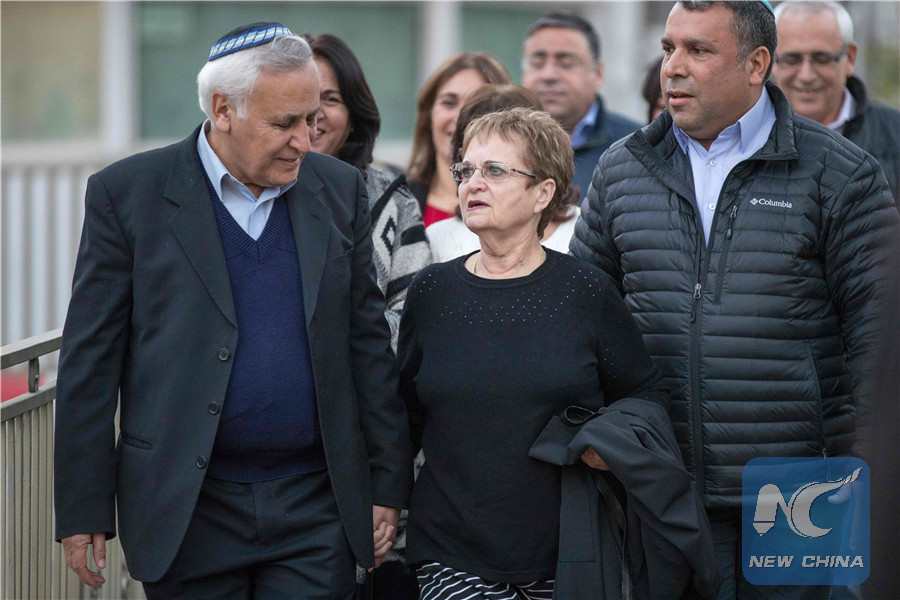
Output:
top-left (522, 12), bottom-right (641, 196)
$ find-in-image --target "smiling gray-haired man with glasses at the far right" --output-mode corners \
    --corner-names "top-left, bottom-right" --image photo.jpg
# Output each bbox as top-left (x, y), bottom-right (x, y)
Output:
top-left (772, 0), bottom-right (900, 200)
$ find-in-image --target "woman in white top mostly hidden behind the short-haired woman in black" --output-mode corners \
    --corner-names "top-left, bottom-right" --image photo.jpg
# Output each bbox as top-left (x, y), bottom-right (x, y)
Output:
top-left (425, 83), bottom-right (579, 262)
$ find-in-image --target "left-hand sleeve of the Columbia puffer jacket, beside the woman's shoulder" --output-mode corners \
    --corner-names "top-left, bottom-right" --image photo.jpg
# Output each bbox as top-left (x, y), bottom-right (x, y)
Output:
top-left (569, 157), bottom-right (622, 293)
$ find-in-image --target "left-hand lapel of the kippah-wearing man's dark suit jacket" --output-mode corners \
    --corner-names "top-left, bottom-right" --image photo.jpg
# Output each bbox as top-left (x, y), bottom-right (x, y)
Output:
top-left (165, 127), bottom-right (237, 327)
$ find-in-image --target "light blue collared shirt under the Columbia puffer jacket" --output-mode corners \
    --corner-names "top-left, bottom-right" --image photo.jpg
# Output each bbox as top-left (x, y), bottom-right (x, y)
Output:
top-left (672, 90), bottom-right (775, 243)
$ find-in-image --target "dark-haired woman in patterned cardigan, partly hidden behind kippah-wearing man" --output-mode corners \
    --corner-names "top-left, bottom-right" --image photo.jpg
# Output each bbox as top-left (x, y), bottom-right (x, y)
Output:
top-left (305, 34), bottom-right (431, 352)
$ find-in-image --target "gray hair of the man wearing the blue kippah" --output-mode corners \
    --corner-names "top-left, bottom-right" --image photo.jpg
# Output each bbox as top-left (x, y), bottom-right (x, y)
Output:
top-left (197, 35), bottom-right (314, 120)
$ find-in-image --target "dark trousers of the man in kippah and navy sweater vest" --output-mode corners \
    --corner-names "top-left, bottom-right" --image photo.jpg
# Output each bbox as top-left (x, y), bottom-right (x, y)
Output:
top-left (144, 471), bottom-right (356, 600)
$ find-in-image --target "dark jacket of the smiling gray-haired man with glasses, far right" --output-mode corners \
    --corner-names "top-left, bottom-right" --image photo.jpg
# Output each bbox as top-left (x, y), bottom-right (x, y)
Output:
top-left (844, 75), bottom-right (900, 202)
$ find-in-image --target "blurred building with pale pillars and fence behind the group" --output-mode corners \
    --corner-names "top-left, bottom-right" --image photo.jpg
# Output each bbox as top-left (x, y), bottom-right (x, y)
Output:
top-left (0, 0), bottom-right (900, 352)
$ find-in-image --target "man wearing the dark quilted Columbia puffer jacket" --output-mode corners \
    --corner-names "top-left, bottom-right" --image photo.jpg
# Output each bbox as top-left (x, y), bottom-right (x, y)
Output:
top-left (571, 2), bottom-right (898, 597)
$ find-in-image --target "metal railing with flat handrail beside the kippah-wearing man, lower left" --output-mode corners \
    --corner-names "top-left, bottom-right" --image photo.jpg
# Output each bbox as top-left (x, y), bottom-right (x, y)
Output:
top-left (0, 329), bottom-right (143, 600)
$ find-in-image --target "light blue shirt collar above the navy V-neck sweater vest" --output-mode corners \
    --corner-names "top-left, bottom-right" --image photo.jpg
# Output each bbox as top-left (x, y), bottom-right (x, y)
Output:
top-left (197, 120), bottom-right (297, 240)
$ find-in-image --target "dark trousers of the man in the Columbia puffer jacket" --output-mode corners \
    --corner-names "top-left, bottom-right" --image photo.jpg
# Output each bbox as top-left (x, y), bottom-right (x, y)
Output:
top-left (709, 509), bottom-right (832, 600)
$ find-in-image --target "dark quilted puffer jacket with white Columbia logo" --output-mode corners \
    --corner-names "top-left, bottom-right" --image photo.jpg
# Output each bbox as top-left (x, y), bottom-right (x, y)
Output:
top-left (571, 84), bottom-right (898, 507)
